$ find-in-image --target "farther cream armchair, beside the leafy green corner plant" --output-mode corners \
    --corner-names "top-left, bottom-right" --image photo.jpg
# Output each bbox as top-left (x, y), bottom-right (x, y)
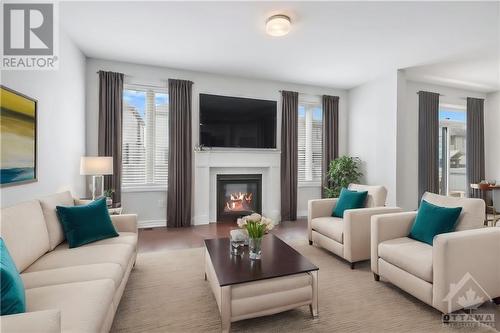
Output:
top-left (307, 184), bottom-right (402, 269)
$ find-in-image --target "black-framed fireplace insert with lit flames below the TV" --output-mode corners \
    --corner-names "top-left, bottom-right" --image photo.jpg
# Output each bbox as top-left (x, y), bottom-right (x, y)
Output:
top-left (217, 174), bottom-right (262, 222)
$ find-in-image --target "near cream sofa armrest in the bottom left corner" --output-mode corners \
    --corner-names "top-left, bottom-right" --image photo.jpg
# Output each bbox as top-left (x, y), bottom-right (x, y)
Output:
top-left (0, 310), bottom-right (61, 333)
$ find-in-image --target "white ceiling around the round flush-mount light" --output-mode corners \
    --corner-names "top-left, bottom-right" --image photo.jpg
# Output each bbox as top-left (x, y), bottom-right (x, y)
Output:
top-left (59, 1), bottom-right (500, 90)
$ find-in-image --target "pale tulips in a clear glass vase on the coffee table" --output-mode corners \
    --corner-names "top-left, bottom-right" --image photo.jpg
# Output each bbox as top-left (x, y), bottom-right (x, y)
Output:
top-left (238, 213), bottom-right (274, 260)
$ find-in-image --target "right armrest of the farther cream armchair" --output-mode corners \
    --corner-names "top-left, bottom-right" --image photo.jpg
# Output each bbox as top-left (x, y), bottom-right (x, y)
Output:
top-left (344, 207), bottom-right (402, 262)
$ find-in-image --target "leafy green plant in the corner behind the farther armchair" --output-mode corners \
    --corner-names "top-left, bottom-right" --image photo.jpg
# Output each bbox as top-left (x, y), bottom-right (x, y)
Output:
top-left (324, 155), bottom-right (363, 198)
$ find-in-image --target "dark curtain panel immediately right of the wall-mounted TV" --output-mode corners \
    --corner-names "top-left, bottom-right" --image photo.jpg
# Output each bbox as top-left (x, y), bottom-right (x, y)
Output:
top-left (281, 91), bottom-right (299, 221)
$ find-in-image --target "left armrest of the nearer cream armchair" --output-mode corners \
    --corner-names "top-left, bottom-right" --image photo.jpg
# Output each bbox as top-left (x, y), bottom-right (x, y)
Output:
top-left (370, 212), bottom-right (417, 274)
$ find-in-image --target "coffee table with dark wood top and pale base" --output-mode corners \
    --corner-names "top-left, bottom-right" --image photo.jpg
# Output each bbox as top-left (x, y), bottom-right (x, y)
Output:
top-left (205, 234), bottom-right (319, 332)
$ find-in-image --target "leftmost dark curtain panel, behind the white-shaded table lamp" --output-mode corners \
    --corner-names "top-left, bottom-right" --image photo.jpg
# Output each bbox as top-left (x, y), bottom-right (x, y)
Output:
top-left (98, 71), bottom-right (123, 206)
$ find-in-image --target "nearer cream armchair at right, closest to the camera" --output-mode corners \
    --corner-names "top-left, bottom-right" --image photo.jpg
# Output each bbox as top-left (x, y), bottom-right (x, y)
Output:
top-left (371, 193), bottom-right (500, 313)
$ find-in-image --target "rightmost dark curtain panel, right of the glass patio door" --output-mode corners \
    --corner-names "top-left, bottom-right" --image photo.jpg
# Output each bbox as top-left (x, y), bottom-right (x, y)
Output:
top-left (466, 97), bottom-right (486, 199)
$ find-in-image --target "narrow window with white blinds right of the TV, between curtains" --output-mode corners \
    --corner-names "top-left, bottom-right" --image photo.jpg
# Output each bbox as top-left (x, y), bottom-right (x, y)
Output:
top-left (298, 100), bottom-right (323, 186)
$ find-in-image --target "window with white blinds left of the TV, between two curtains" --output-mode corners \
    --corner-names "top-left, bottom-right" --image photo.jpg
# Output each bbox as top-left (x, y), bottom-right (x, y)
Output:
top-left (122, 85), bottom-right (168, 190)
